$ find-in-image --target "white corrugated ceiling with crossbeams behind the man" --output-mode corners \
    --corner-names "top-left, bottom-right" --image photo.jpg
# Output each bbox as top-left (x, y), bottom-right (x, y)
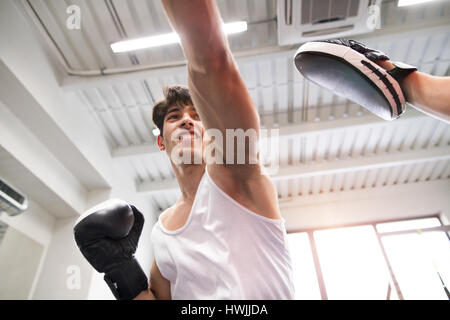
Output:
top-left (18, 0), bottom-right (450, 215)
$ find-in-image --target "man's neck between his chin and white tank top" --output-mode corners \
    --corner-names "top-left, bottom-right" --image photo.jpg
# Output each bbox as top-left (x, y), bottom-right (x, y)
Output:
top-left (172, 163), bottom-right (206, 202)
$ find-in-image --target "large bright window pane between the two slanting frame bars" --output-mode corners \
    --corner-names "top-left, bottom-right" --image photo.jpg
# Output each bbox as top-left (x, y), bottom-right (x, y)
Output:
top-left (314, 226), bottom-right (390, 300)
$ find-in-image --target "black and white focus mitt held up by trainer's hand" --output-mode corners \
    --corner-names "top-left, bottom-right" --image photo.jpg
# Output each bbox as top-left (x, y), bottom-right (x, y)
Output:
top-left (294, 39), bottom-right (417, 120)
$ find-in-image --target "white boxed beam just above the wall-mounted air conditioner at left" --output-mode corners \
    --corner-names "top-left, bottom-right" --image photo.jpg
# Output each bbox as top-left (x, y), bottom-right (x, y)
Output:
top-left (0, 101), bottom-right (88, 217)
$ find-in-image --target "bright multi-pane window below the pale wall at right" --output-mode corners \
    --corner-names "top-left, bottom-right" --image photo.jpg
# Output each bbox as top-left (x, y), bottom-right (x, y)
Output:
top-left (288, 217), bottom-right (450, 300)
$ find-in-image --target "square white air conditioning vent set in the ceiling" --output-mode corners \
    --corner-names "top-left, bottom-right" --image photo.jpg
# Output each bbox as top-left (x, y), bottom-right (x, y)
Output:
top-left (277, 0), bottom-right (381, 45)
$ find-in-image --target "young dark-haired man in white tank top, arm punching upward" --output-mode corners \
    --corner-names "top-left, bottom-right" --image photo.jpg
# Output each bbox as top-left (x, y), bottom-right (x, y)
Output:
top-left (137, 0), bottom-right (294, 299)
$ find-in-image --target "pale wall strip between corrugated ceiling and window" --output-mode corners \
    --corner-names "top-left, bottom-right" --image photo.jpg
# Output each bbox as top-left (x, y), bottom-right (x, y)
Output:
top-left (280, 180), bottom-right (450, 232)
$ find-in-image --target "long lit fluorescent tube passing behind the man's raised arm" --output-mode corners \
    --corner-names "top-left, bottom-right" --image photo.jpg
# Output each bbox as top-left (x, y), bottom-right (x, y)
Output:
top-left (111, 21), bottom-right (247, 53)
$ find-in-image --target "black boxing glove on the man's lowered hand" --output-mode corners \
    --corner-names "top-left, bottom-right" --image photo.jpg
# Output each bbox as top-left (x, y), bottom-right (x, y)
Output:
top-left (74, 199), bottom-right (148, 300)
